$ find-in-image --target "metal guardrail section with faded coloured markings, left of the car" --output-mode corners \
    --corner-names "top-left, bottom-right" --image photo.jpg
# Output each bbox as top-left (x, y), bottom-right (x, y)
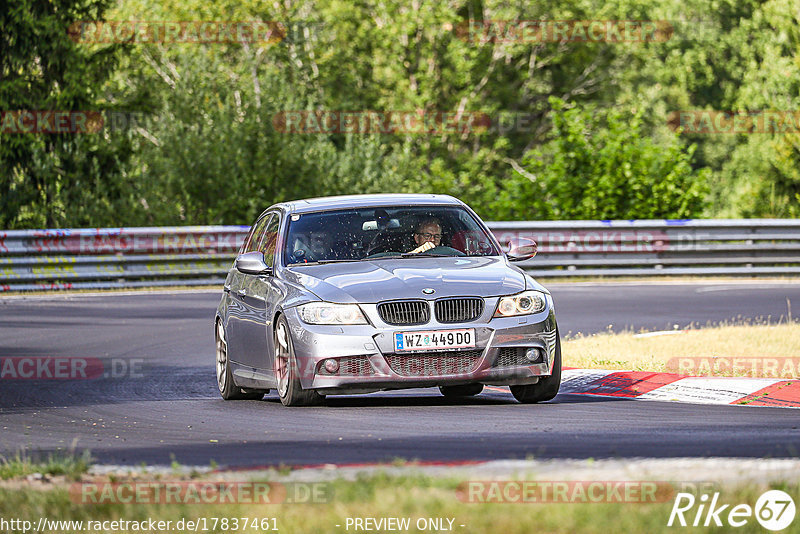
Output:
top-left (0, 226), bottom-right (250, 292)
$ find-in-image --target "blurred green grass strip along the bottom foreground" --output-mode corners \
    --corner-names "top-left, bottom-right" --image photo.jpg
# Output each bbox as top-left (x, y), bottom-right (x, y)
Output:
top-left (0, 473), bottom-right (800, 534)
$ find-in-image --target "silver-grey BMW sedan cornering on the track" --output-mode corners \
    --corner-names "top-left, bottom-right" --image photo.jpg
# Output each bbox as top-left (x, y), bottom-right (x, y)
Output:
top-left (214, 195), bottom-right (561, 406)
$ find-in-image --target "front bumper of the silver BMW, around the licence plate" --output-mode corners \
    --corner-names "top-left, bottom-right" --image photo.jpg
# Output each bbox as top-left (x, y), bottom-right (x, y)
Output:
top-left (285, 302), bottom-right (557, 394)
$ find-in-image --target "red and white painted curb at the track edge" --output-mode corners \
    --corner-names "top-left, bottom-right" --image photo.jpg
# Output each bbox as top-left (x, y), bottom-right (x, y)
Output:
top-left (559, 369), bottom-right (800, 408)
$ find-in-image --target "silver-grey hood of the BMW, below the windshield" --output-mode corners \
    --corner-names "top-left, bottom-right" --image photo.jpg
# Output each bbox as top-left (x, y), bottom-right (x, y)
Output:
top-left (284, 257), bottom-right (525, 303)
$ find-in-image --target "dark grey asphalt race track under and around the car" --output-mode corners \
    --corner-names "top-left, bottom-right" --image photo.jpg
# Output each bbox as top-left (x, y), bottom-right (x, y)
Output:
top-left (0, 282), bottom-right (800, 466)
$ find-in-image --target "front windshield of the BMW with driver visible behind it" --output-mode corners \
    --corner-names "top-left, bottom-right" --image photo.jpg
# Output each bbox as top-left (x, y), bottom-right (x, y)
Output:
top-left (283, 206), bottom-right (499, 265)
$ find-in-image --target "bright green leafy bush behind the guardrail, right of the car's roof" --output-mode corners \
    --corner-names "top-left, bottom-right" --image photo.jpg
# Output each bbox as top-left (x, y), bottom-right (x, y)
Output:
top-left (498, 98), bottom-right (707, 219)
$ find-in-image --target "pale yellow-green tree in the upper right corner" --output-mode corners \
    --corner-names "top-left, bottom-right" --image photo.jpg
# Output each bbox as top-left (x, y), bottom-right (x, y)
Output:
top-left (618, 0), bottom-right (800, 217)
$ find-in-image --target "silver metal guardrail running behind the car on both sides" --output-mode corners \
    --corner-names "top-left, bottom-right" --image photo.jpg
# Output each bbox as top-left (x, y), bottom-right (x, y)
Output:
top-left (0, 219), bottom-right (800, 292)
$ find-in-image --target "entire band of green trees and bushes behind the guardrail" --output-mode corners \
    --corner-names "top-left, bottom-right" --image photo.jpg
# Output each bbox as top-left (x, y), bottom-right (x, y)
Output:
top-left (0, 0), bottom-right (800, 228)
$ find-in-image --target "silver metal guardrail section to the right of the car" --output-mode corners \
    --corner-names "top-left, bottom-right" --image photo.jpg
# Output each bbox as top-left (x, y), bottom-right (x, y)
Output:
top-left (500, 219), bottom-right (800, 277)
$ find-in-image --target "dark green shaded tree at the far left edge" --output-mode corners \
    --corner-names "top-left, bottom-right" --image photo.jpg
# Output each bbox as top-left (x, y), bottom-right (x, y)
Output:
top-left (0, 0), bottom-right (129, 228)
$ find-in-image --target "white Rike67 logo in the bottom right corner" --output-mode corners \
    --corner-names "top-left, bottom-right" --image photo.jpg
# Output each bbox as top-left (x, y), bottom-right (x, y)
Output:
top-left (667, 490), bottom-right (796, 531)
